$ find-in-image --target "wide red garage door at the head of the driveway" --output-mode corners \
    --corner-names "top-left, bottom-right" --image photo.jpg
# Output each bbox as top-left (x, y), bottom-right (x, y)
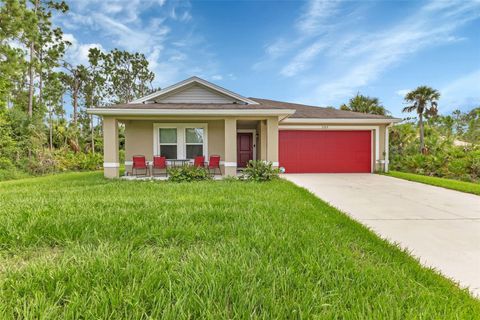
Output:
top-left (279, 130), bottom-right (372, 173)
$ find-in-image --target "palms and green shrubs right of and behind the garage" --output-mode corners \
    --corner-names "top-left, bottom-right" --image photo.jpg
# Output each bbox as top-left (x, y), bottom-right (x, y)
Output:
top-left (340, 86), bottom-right (480, 182)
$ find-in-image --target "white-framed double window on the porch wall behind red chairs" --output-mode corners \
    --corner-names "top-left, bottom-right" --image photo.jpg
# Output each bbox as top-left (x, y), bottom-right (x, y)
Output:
top-left (154, 123), bottom-right (207, 159)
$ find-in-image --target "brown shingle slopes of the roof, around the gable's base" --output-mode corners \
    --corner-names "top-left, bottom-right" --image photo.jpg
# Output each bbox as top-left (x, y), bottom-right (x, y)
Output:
top-left (108, 98), bottom-right (392, 119)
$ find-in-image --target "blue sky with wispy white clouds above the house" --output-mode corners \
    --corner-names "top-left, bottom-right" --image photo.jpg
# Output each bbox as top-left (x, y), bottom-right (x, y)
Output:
top-left (55, 0), bottom-right (480, 116)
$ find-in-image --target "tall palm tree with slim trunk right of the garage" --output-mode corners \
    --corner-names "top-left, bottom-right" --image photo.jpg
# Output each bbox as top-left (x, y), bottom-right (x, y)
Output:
top-left (403, 86), bottom-right (440, 153)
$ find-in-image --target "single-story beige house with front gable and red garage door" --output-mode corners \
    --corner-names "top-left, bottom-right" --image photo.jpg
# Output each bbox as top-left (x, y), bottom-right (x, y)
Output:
top-left (88, 77), bottom-right (399, 178)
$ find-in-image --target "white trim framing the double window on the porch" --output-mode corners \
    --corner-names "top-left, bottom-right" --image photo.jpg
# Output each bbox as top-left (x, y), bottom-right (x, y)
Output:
top-left (153, 123), bottom-right (208, 159)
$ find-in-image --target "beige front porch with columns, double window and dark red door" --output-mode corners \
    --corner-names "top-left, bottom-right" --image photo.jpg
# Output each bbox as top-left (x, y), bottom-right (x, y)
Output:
top-left (103, 116), bottom-right (279, 179)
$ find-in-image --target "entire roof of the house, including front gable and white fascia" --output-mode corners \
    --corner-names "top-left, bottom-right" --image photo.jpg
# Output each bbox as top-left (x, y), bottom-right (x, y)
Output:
top-left (87, 77), bottom-right (400, 123)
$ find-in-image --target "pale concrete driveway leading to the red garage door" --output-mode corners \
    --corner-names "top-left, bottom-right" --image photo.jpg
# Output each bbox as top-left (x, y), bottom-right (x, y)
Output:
top-left (283, 174), bottom-right (480, 297)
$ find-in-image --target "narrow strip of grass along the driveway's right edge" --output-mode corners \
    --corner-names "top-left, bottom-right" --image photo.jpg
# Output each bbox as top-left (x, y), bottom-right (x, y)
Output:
top-left (386, 171), bottom-right (480, 195)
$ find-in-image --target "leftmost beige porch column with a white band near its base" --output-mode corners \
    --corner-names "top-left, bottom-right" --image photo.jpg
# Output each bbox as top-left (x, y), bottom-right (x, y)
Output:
top-left (103, 117), bottom-right (120, 178)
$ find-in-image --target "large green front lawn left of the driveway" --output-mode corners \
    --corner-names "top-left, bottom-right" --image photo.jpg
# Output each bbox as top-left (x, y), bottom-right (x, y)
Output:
top-left (0, 172), bottom-right (480, 319)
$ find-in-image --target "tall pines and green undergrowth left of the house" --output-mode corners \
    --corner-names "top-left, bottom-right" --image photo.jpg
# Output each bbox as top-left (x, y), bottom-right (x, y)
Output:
top-left (0, 0), bottom-right (154, 178)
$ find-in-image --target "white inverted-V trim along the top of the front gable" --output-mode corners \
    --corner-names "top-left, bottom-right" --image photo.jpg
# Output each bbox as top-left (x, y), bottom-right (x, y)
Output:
top-left (129, 76), bottom-right (257, 104)
